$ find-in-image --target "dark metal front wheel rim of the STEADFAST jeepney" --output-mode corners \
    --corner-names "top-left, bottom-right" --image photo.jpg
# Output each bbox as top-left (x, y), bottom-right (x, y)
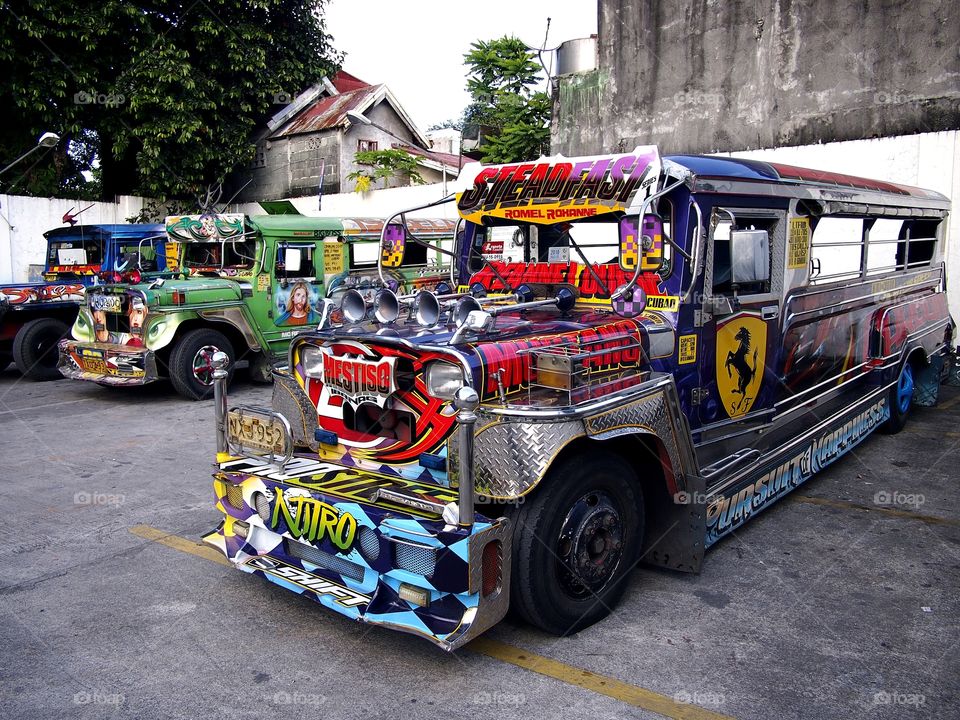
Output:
top-left (557, 492), bottom-right (624, 598)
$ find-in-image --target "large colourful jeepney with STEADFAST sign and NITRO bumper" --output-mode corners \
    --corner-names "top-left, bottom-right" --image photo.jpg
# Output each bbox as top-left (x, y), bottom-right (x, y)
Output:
top-left (204, 147), bottom-right (954, 649)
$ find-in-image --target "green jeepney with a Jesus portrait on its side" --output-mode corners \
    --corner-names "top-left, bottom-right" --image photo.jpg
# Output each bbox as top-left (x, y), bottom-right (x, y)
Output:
top-left (59, 214), bottom-right (454, 399)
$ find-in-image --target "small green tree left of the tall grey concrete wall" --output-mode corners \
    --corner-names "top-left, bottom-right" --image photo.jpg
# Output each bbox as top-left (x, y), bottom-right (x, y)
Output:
top-left (463, 36), bottom-right (551, 163)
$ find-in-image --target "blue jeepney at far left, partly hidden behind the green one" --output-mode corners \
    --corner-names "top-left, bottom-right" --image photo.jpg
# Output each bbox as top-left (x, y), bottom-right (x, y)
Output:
top-left (0, 224), bottom-right (166, 380)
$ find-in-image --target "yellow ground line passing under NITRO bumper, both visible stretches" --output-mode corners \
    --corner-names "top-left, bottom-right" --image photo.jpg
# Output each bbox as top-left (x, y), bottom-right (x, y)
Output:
top-left (130, 525), bottom-right (734, 720)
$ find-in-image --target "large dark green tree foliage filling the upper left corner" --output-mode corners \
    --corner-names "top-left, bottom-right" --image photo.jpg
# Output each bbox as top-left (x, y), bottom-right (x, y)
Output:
top-left (0, 0), bottom-right (341, 197)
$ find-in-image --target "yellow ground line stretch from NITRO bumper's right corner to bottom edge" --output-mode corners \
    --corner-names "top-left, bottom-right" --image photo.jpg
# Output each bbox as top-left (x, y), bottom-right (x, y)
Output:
top-left (464, 637), bottom-right (733, 720)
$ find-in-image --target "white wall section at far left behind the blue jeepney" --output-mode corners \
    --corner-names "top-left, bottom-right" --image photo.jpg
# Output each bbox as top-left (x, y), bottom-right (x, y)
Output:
top-left (0, 195), bottom-right (150, 283)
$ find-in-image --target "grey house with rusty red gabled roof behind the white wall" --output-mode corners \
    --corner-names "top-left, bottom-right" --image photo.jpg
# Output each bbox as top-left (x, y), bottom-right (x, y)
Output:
top-left (238, 71), bottom-right (463, 202)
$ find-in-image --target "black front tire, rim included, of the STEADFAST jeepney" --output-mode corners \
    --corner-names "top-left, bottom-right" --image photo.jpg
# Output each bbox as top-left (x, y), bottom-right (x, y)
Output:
top-left (510, 454), bottom-right (644, 635)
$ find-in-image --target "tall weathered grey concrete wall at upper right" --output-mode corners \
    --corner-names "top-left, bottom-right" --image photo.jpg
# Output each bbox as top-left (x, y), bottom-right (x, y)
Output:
top-left (552, 0), bottom-right (960, 155)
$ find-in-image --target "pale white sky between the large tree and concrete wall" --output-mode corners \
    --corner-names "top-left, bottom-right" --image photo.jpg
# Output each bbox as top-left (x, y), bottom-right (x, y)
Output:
top-left (325, 0), bottom-right (597, 130)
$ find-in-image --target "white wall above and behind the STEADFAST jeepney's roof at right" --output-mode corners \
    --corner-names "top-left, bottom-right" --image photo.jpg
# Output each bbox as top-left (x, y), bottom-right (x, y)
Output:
top-left (720, 130), bottom-right (960, 322)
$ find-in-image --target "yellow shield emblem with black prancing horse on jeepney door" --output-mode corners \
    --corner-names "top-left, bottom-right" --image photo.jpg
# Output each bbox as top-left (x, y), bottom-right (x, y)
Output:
top-left (717, 312), bottom-right (767, 418)
